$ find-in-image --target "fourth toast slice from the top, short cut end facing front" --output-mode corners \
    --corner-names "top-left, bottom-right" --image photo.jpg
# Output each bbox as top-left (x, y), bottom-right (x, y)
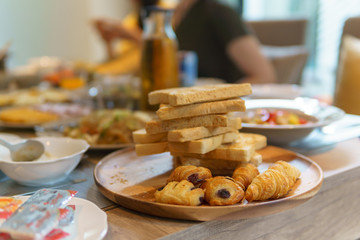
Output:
top-left (168, 117), bottom-right (241, 142)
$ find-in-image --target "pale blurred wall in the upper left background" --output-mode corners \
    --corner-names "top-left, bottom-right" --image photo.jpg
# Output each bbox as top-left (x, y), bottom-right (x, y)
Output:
top-left (0, 0), bottom-right (131, 68)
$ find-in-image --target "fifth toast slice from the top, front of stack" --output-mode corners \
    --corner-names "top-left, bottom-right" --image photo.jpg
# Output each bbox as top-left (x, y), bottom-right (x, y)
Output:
top-left (169, 131), bottom-right (239, 154)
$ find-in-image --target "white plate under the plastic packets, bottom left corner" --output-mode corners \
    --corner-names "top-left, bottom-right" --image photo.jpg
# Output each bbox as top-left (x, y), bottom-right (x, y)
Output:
top-left (6, 197), bottom-right (108, 240)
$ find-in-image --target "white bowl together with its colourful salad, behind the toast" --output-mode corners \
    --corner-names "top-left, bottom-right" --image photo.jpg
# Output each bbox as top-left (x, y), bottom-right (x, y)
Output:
top-left (236, 97), bottom-right (345, 145)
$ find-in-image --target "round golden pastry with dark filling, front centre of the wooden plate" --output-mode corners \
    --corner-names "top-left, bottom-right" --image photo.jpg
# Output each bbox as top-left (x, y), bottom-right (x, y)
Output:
top-left (201, 176), bottom-right (244, 206)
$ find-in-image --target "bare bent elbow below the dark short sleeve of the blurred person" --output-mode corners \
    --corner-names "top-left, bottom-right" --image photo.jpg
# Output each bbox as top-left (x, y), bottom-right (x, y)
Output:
top-left (226, 35), bottom-right (276, 83)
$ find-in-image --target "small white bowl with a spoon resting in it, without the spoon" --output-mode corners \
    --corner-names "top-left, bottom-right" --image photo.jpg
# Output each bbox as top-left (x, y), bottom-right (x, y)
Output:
top-left (0, 137), bottom-right (89, 186)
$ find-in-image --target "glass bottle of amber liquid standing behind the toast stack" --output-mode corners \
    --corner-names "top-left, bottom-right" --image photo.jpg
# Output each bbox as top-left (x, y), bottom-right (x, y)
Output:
top-left (140, 7), bottom-right (180, 111)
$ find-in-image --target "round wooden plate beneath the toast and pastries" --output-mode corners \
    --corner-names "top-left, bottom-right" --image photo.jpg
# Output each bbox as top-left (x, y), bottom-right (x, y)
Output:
top-left (94, 146), bottom-right (323, 221)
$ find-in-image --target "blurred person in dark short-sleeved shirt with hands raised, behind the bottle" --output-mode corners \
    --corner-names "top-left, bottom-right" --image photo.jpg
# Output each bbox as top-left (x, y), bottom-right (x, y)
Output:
top-left (95, 0), bottom-right (276, 84)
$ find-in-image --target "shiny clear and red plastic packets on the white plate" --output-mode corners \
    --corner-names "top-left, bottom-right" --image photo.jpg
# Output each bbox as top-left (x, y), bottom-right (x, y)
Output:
top-left (0, 189), bottom-right (76, 239)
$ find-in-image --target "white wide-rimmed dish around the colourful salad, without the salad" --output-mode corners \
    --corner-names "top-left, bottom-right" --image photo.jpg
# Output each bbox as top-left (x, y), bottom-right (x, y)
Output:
top-left (236, 98), bottom-right (345, 145)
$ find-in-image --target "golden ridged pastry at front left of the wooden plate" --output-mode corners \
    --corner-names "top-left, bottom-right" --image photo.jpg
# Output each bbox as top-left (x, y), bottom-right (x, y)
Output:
top-left (155, 180), bottom-right (204, 206)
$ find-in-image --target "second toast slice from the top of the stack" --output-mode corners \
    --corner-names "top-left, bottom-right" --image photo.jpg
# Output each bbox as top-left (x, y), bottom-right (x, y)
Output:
top-left (156, 98), bottom-right (246, 120)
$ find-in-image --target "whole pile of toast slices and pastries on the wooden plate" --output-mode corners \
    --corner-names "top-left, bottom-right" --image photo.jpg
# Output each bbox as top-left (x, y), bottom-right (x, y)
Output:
top-left (134, 84), bottom-right (300, 206)
